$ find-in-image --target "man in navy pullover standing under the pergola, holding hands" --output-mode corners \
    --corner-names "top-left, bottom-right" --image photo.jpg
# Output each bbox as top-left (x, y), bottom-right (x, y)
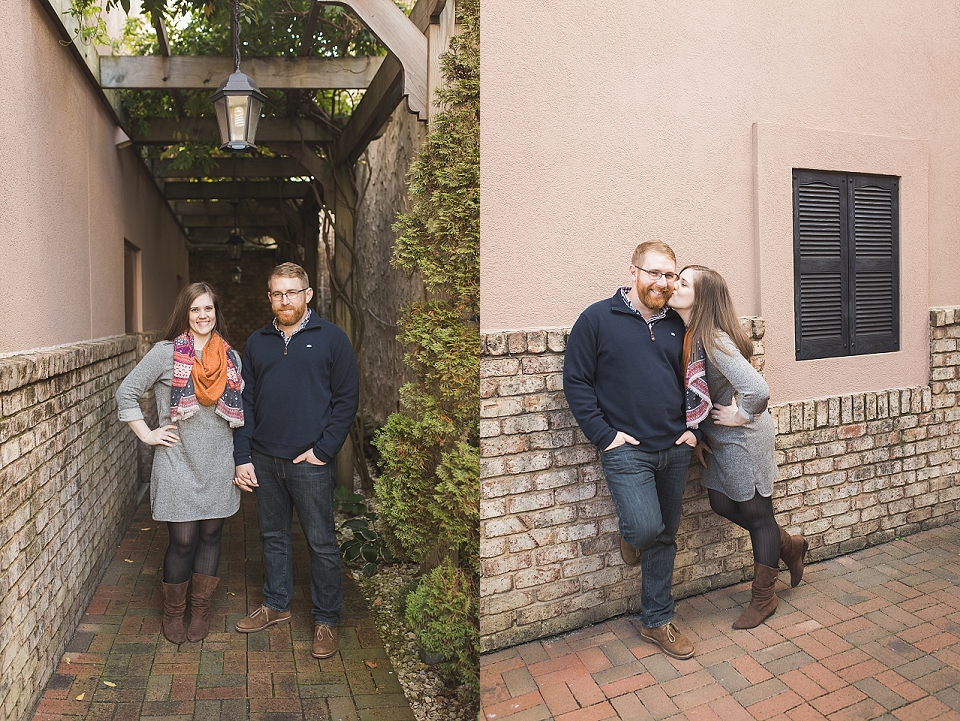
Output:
top-left (233, 263), bottom-right (360, 658)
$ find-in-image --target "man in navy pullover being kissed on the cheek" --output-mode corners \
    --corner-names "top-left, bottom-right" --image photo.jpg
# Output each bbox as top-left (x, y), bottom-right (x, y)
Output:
top-left (563, 241), bottom-right (697, 658)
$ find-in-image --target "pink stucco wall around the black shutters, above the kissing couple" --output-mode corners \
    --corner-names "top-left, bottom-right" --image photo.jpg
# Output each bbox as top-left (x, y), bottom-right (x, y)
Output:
top-left (481, 0), bottom-right (960, 403)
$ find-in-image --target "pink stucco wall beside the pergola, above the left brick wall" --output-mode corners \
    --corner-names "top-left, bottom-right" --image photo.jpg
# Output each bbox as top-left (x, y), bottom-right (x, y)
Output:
top-left (0, 0), bottom-right (188, 353)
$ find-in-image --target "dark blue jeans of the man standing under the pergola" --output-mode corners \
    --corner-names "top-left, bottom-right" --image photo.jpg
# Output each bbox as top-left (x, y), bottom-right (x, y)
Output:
top-left (252, 451), bottom-right (343, 626)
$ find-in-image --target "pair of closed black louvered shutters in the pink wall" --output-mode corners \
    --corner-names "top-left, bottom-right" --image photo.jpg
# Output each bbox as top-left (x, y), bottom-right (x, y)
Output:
top-left (793, 170), bottom-right (900, 360)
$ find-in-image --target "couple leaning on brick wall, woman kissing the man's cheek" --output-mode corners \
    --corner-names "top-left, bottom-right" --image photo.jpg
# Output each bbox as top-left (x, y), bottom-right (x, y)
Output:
top-left (563, 241), bottom-right (807, 659)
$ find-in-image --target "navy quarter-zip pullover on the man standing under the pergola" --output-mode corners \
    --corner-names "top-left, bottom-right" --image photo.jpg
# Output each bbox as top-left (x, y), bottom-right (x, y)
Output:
top-left (233, 313), bottom-right (360, 466)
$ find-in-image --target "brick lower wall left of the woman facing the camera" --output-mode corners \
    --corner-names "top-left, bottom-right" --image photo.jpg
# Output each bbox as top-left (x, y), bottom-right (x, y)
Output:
top-left (0, 336), bottom-right (137, 719)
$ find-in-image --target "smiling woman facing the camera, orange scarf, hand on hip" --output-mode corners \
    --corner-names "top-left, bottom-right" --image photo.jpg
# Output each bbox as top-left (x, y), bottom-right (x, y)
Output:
top-left (117, 283), bottom-right (243, 644)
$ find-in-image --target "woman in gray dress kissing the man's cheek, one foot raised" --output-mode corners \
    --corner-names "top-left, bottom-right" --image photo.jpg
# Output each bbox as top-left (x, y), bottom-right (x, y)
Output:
top-left (670, 265), bottom-right (807, 628)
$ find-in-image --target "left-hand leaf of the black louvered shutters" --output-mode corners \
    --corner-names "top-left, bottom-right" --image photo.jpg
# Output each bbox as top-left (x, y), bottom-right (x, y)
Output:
top-left (793, 170), bottom-right (850, 360)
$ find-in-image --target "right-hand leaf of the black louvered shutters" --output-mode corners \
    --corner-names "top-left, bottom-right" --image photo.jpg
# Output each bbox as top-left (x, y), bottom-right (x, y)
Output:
top-left (849, 176), bottom-right (900, 355)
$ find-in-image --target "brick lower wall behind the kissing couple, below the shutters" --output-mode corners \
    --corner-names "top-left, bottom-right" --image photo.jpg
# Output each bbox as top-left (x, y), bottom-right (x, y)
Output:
top-left (480, 308), bottom-right (960, 650)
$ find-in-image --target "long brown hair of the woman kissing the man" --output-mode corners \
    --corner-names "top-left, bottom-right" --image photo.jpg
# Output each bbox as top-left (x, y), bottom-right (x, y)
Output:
top-left (680, 265), bottom-right (753, 364)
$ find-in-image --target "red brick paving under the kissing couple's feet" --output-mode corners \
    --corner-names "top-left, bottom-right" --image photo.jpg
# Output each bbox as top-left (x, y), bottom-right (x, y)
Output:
top-left (481, 524), bottom-right (960, 721)
